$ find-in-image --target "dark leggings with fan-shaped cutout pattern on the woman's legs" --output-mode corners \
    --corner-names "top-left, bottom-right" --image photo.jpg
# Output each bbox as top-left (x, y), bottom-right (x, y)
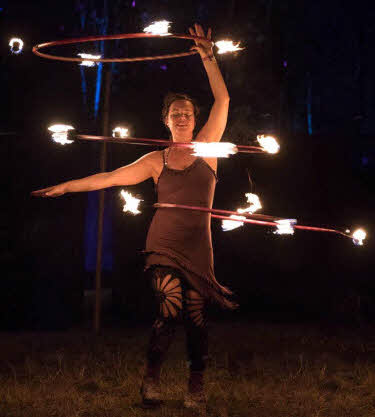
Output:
top-left (147, 266), bottom-right (208, 379)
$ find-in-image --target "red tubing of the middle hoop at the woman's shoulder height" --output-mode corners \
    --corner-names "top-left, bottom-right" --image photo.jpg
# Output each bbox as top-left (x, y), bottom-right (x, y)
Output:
top-left (74, 135), bottom-right (268, 154)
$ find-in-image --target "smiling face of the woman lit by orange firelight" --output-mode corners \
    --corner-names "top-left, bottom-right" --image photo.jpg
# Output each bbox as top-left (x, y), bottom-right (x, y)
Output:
top-left (165, 100), bottom-right (195, 141)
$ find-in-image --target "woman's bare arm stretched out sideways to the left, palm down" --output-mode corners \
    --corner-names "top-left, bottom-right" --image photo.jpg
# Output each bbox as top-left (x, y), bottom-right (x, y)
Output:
top-left (31, 151), bottom-right (159, 197)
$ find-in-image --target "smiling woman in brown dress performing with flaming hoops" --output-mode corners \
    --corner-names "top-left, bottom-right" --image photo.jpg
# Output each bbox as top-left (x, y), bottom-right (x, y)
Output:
top-left (32, 24), bottom-right (236, 411)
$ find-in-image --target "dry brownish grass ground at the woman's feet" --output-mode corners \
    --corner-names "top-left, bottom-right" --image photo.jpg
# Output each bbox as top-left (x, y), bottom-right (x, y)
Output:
top-left (0, 322), bottom-right (375, 417)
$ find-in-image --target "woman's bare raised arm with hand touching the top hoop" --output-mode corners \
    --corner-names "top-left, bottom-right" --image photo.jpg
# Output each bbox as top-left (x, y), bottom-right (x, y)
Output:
top-left (189, 24), bottom-right (229, 142)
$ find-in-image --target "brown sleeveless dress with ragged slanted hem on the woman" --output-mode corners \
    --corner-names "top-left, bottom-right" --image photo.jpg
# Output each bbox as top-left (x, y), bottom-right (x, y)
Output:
top-left (144, 148), bottom-right (236, 309)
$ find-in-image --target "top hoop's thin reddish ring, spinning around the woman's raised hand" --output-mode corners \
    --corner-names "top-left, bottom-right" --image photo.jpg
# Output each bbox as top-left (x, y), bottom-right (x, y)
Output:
top-left (32, 33), bottom-right (212, 62)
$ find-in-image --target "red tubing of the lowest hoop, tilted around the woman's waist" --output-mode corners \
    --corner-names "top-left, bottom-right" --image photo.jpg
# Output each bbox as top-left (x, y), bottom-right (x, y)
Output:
top-left (154, 203), bottom-right (352, 239)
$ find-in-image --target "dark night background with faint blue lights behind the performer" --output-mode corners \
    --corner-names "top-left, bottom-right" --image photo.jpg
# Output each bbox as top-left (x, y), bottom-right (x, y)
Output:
top-left (0, 0), bottom-right (375, 330)
